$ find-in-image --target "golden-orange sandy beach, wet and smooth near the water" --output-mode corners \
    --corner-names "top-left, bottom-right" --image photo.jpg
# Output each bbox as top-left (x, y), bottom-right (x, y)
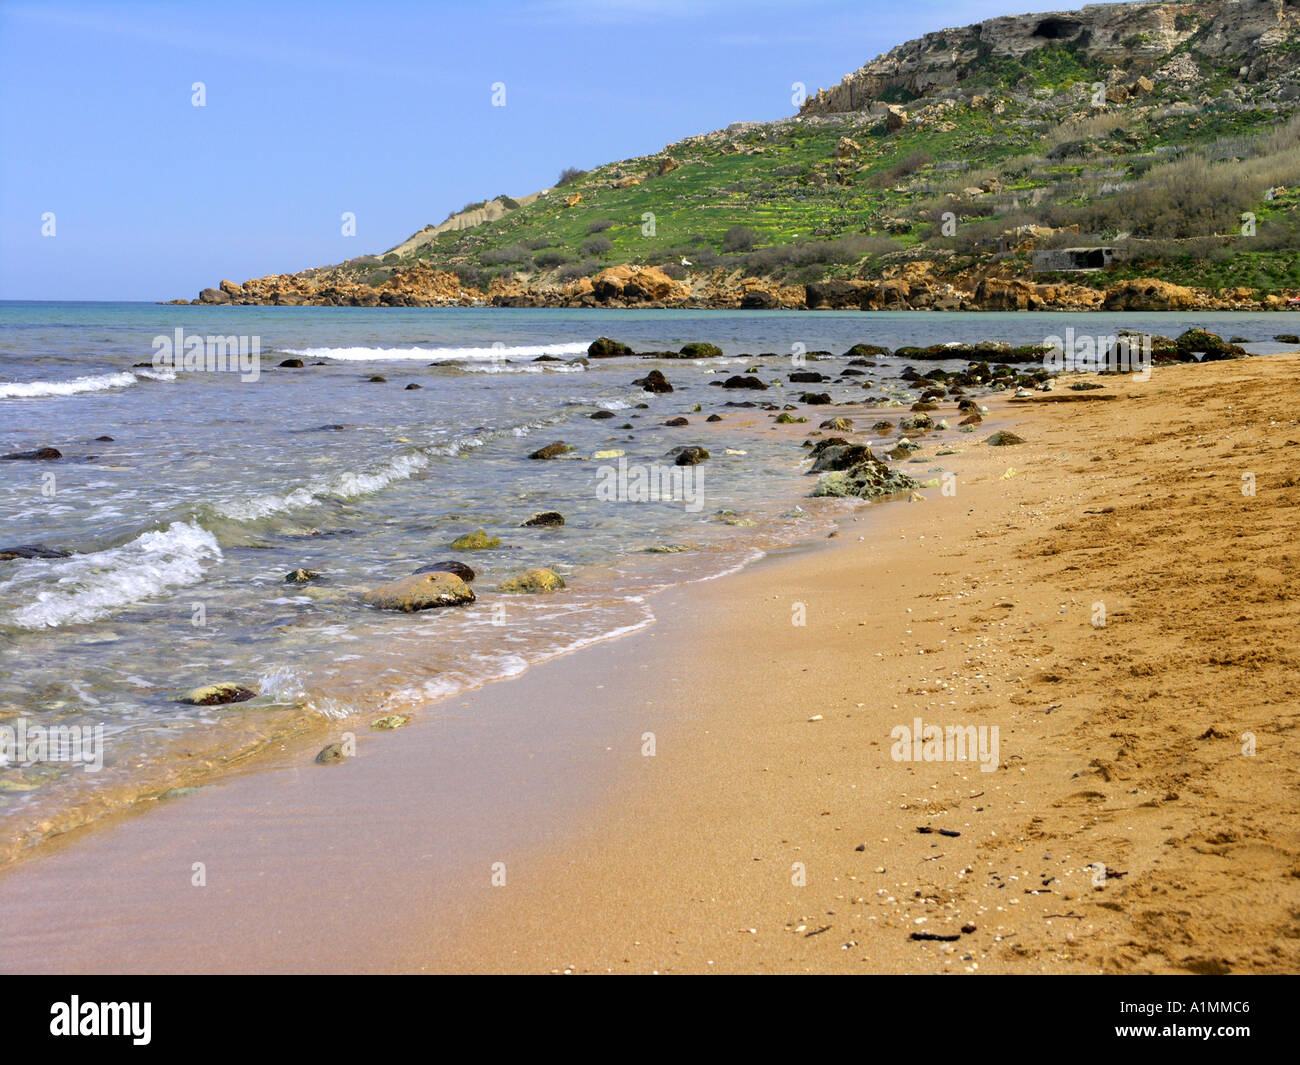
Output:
top-left (0, 355), bottom-right (1300, 973)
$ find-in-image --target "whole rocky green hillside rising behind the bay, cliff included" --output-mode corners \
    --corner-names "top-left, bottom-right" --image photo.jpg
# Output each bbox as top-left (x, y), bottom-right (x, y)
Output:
top-left (189, 0), bottom-right (1300, 309)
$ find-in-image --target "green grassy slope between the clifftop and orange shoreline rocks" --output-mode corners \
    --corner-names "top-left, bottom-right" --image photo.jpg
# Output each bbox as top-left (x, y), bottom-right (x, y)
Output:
top-left (338, 40), bottom-right (1300, 297)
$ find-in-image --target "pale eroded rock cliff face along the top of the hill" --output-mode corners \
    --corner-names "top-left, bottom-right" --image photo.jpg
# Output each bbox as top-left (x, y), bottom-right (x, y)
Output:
top-left (801, 0), bottom-right (1300, 114)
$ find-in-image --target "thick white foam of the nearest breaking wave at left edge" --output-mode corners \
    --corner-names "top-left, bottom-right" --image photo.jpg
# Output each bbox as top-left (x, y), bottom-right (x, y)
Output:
top-left (0, 521), bottom-right (221, 628)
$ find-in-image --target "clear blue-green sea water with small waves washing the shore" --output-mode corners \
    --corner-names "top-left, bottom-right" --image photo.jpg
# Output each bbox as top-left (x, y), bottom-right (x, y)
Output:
top-left (0, 303), bottom-right (1294, 847)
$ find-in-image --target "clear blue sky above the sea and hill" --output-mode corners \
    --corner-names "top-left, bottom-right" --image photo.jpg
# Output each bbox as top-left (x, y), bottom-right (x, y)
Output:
top-left (0, 0), bottom-right (1123, 300)
